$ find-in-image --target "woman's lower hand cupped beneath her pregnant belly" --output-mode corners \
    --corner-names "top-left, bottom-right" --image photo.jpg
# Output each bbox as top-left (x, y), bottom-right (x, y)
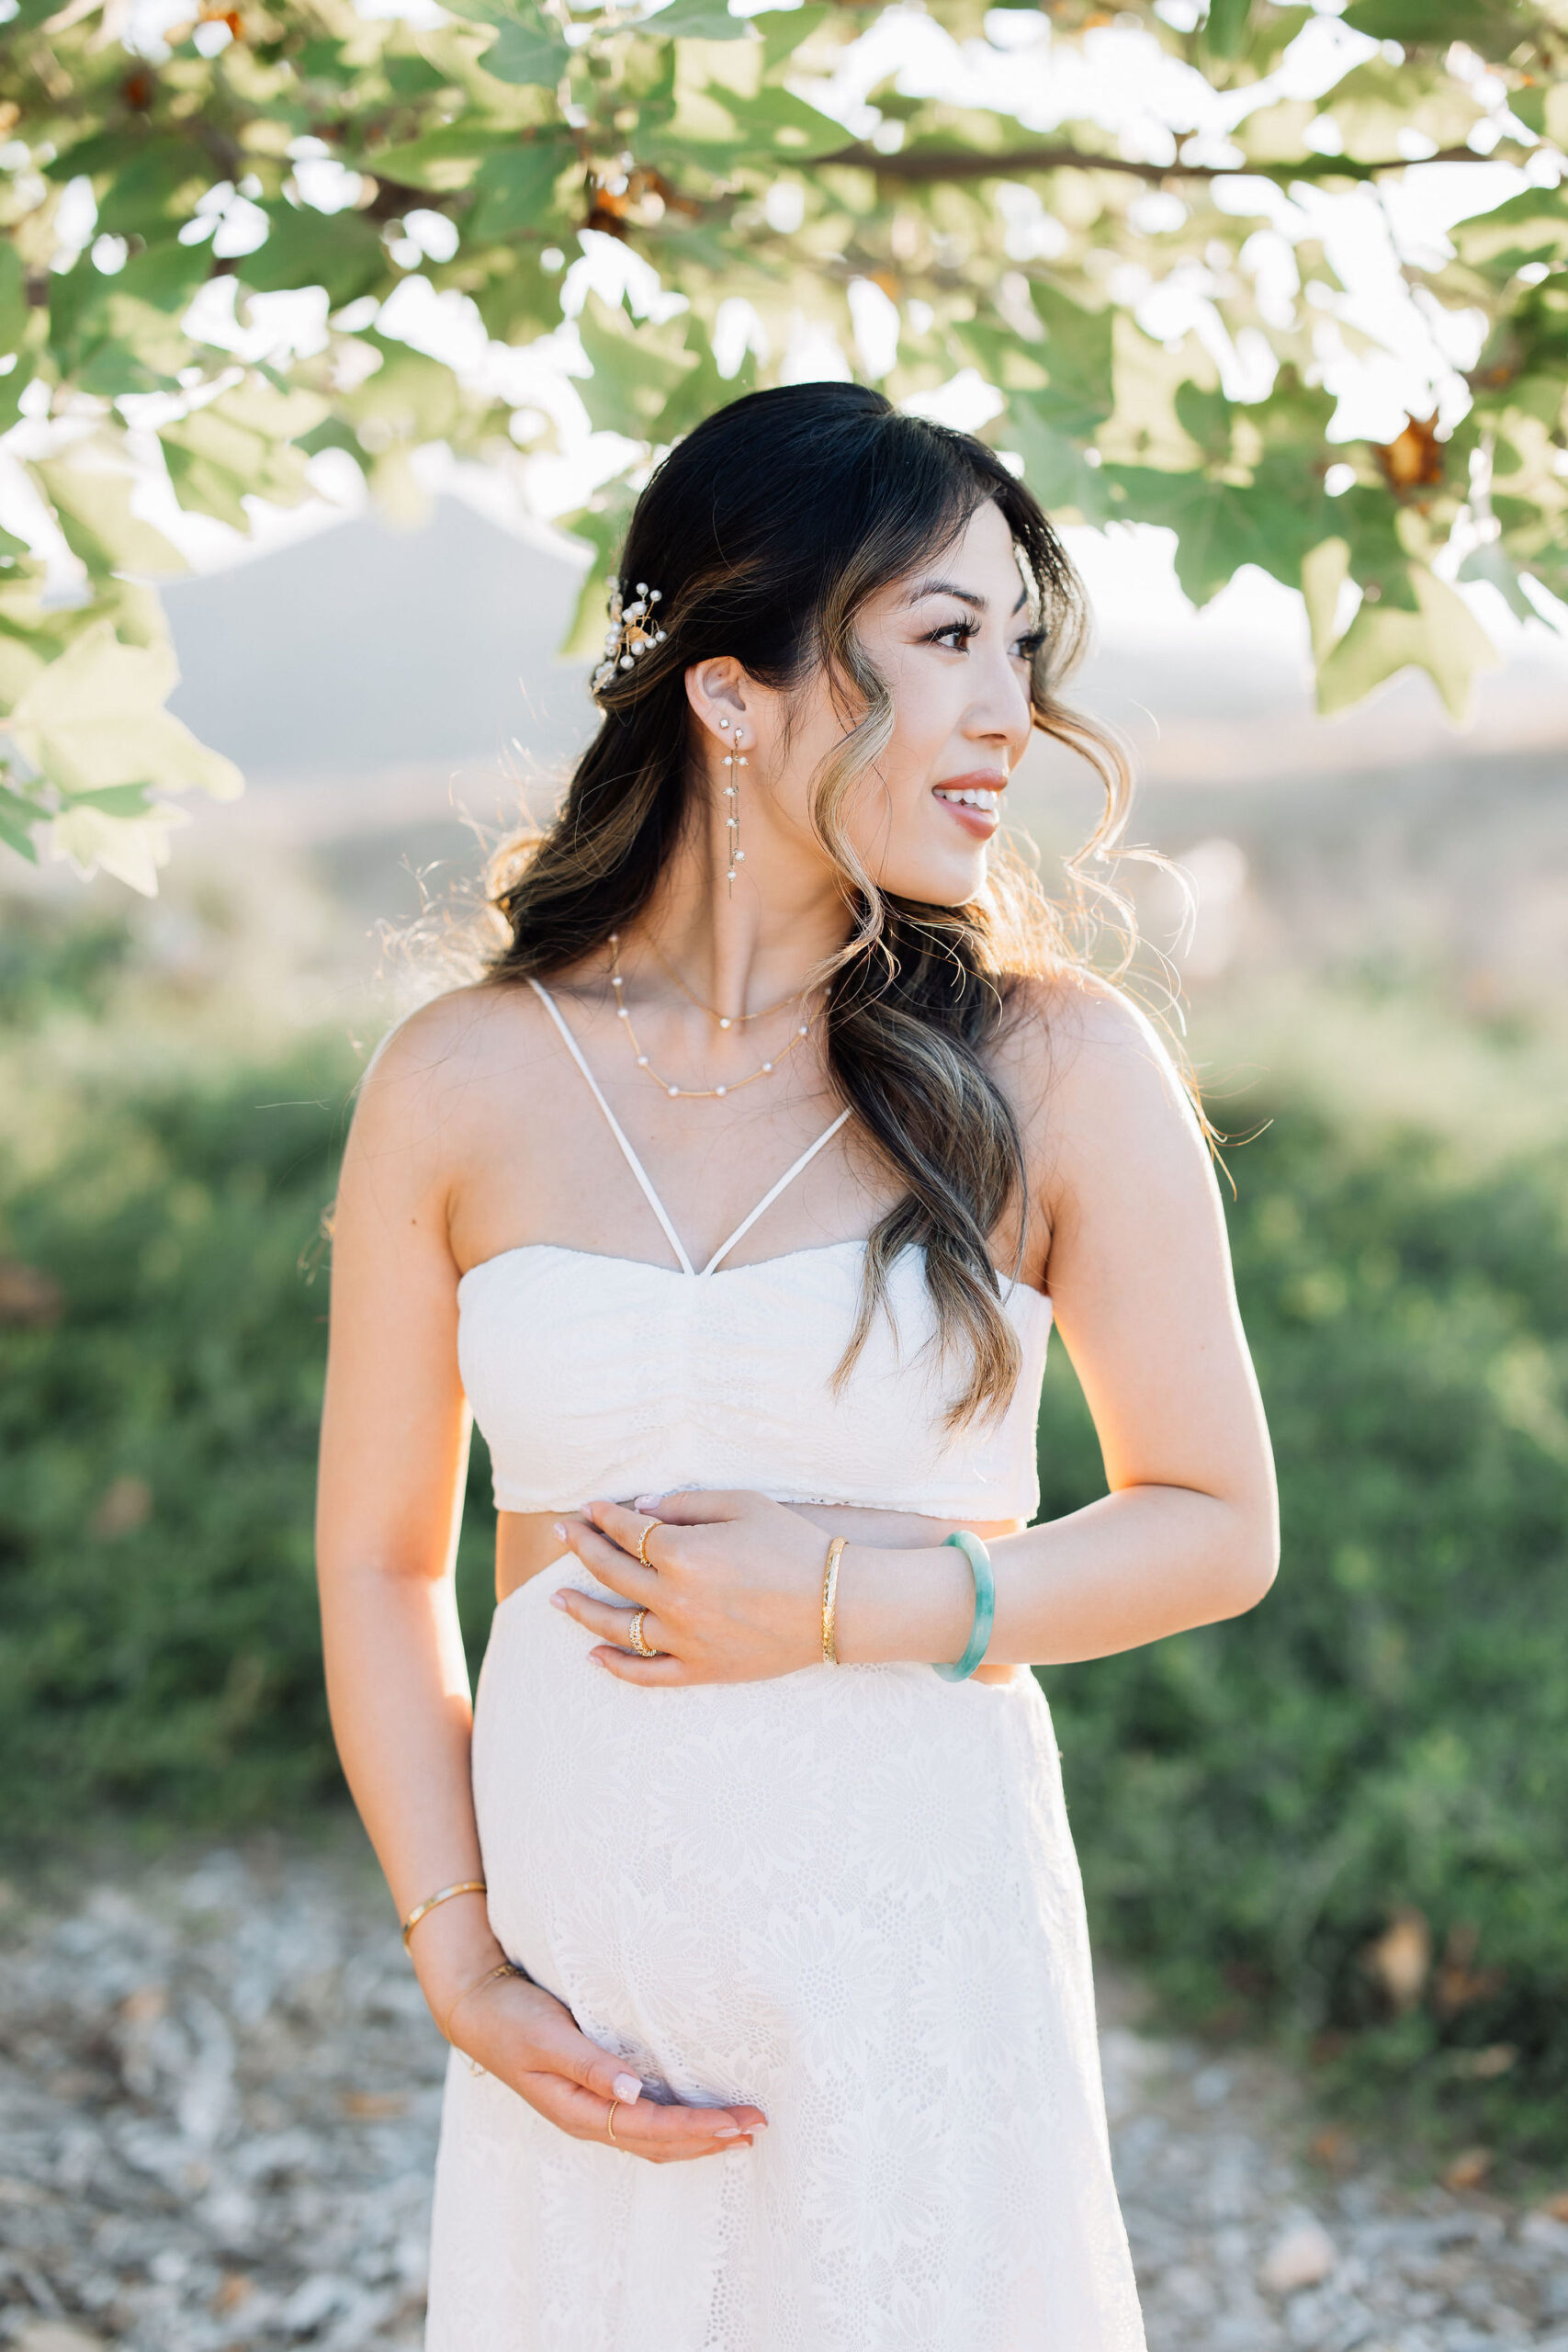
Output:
top-left (437, 1975), bottom-right (766, 2164)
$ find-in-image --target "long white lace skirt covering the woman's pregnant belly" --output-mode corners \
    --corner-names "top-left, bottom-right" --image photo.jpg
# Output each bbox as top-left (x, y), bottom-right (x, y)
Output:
top-left (425, 1559), bottom-right (1143, 2352)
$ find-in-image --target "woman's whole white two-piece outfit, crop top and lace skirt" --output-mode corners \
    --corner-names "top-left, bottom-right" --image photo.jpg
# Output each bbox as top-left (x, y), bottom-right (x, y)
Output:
top-left (425, 990), bottom-right (1145, 2352)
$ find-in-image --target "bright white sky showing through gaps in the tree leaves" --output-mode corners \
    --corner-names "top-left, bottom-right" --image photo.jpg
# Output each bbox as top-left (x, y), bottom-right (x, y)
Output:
top-left (0, 0), bottom-right (1556, 668)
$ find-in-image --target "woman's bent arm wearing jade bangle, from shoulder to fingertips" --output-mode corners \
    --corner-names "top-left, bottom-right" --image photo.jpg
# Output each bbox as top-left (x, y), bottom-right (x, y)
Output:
top-left (549, 992), bottom-right (1279, 1681)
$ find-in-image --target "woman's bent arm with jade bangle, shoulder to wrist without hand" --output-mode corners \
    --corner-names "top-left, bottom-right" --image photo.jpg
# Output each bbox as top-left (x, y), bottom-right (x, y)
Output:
top-left (840, 992), bottom-right (1279, 1665)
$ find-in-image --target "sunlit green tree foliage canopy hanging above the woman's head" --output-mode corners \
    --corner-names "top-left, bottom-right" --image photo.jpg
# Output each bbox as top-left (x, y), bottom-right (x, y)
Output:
top-left (0, 0), bottom-right (1568, 889)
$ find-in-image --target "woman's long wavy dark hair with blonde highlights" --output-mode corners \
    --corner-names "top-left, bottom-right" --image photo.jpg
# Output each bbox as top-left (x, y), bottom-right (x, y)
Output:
top-left (489, 383), bottom-right (1152, 1428)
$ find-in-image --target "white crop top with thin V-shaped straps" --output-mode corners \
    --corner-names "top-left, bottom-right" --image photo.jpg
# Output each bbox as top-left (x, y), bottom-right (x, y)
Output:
top-left (458, 981), bottom-right (1051, 1520)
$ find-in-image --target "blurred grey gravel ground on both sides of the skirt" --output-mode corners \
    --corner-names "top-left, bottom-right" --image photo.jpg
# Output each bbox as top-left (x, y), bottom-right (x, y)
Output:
top-left (0, 1849), bottom-right (1568, 2352)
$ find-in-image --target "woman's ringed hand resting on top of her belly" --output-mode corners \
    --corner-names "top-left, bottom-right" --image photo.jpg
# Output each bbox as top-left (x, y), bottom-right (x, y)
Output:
top-left (550, 1494), bottom-right (828, 1684)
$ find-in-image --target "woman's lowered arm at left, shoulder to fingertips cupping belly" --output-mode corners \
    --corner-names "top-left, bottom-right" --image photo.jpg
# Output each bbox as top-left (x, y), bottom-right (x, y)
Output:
top-left (317, 997), bottom-right (764, 2162)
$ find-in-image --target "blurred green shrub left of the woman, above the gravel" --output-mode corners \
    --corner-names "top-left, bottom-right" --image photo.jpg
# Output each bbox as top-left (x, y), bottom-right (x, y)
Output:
top-left (0, 1042), bottom-right (487, 1841)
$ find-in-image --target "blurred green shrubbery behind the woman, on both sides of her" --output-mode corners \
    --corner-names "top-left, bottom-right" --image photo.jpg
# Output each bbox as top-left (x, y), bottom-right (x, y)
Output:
top-left (0, 898), bottom-right (1568, 2154)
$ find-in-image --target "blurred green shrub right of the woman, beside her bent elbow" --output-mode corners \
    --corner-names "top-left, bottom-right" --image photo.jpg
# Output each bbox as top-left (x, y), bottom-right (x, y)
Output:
top-left (1042, 1105), bottom-right (1568, 2154)
